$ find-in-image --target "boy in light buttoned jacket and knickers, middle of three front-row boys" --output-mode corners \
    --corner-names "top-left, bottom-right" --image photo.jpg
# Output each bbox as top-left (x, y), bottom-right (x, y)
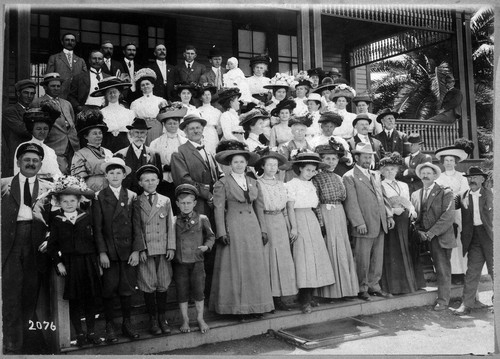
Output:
top-left (134, 165), bottom-right (175, 335)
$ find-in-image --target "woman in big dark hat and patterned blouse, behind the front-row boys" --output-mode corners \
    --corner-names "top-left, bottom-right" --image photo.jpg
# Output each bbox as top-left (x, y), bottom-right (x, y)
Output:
top-left (71, 108), bottom-right (113, 192)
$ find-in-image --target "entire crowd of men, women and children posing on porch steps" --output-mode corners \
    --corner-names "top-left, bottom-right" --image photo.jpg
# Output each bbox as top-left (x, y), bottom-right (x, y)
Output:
top-left (2, 34), bottom-right (493, 353)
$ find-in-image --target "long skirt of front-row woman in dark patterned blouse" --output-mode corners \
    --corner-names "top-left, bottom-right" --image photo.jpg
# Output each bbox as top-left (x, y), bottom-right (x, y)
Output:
top-left (315, 204), bottom-right (359, 298)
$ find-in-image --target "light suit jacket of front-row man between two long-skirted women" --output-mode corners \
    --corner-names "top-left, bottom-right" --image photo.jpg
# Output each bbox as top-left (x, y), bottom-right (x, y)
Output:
top-left (342, 166), bottom-right (393, 238)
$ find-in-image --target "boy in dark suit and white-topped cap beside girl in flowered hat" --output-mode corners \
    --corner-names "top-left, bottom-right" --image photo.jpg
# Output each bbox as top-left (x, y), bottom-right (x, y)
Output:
top-left (93, 157), bottom-right (145, 342)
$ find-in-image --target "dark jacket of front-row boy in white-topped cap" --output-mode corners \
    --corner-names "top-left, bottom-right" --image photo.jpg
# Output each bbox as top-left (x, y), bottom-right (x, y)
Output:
top-left (92, 186), bottom-right (146, 262)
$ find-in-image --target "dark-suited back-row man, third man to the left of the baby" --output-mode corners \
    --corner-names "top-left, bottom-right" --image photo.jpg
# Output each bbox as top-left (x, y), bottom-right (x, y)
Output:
top-left (149, 44), bottom-right (175, 101)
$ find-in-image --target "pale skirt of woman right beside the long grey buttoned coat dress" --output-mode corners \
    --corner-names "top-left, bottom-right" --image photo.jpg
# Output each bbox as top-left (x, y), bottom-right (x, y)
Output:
top-left (264, 213), bottom-right (298, 297)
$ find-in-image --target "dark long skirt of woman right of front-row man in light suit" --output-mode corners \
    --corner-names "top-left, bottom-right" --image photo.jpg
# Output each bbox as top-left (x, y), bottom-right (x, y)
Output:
top-left (380, 210), bottom-right (418, 294)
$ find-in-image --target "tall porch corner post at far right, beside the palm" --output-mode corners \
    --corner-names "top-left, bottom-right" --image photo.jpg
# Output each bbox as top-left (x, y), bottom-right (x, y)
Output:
top-left (464, 13), bottom-right (479, 158)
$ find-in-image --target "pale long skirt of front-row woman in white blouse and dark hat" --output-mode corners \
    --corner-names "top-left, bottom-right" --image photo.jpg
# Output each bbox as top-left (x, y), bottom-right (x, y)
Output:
top-left (293, 208), bottom-right (335, 288)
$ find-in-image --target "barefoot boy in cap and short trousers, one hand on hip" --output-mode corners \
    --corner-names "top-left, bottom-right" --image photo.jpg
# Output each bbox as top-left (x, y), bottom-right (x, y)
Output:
top-left (174, 184), bottom-right (215, 333)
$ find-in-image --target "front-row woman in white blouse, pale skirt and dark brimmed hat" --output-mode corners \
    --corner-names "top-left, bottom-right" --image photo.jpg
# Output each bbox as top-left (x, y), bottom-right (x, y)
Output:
top-left (285, 152), bottom-right (335, 314)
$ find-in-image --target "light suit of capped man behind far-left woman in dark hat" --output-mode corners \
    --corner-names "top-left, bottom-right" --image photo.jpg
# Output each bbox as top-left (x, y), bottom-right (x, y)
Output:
top-left (32, 95), bottom-right (80, 174)
